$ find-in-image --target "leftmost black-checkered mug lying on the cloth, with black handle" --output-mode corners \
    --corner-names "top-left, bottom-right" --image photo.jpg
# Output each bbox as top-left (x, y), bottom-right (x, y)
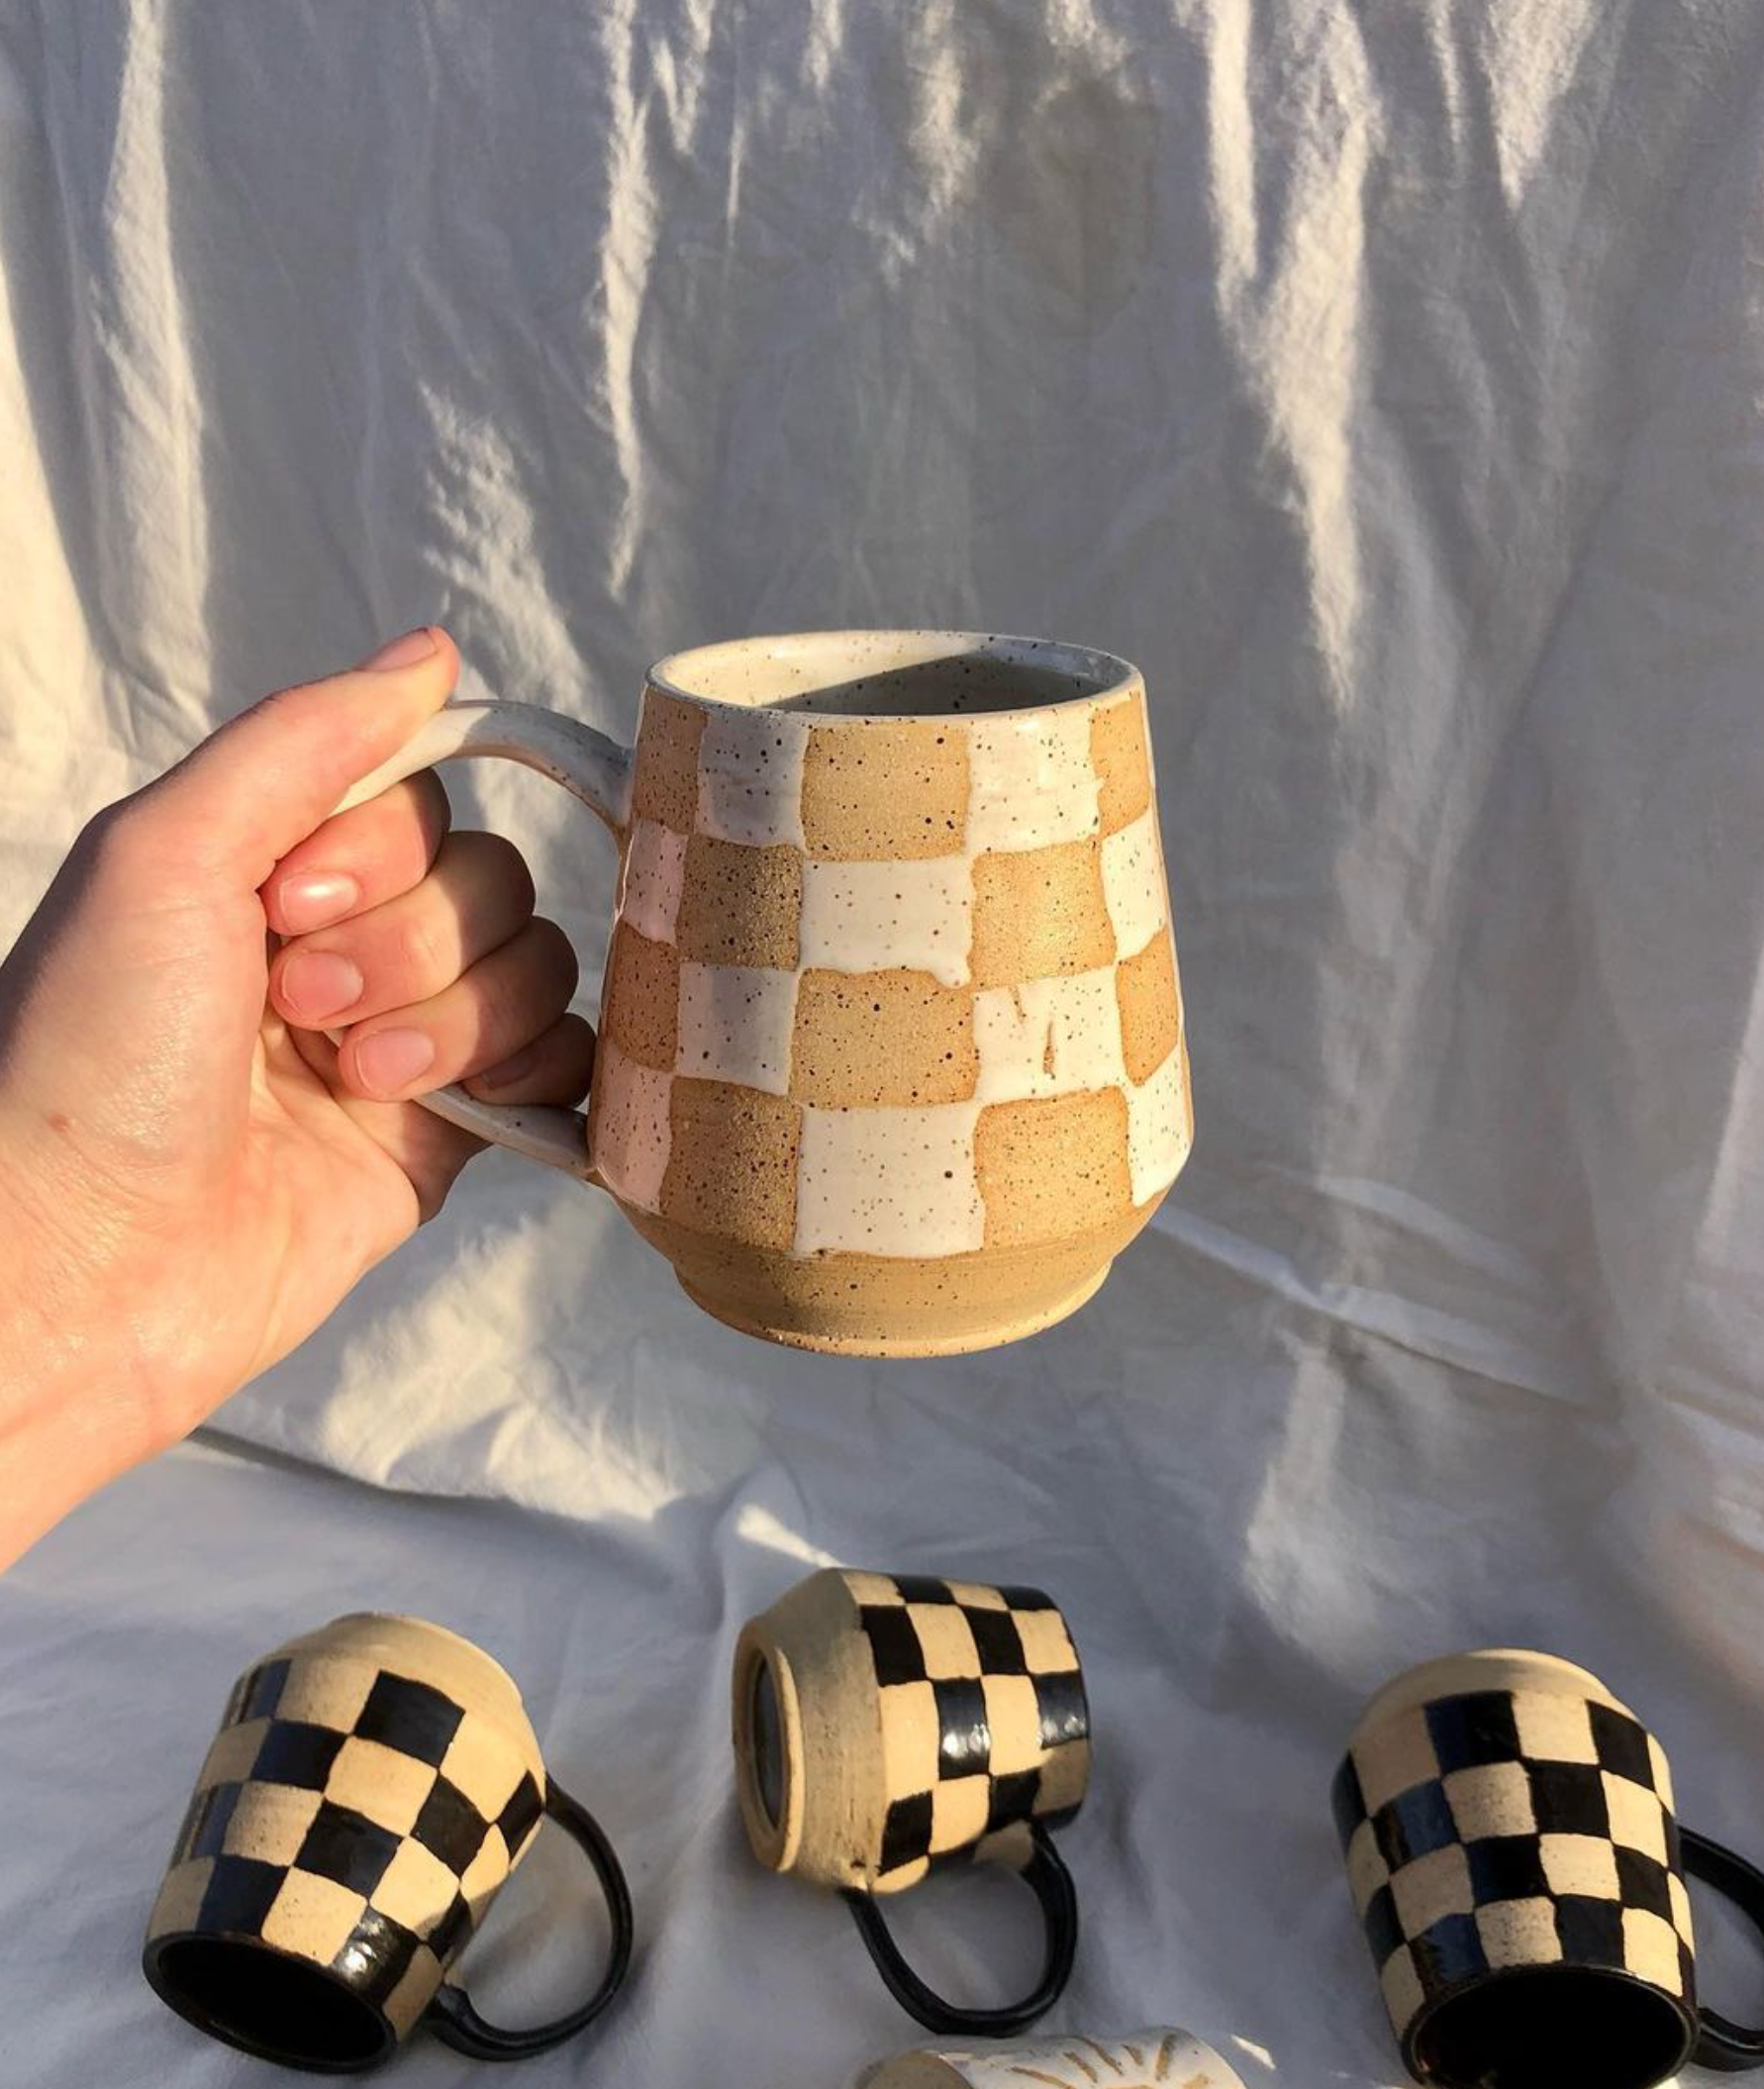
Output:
top-left (142, 1615), bottom-right (631, 2074)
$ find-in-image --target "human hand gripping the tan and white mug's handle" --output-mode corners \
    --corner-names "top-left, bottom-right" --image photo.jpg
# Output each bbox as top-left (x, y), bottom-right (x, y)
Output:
top-left (0, 629), bottom-right (593, 1560)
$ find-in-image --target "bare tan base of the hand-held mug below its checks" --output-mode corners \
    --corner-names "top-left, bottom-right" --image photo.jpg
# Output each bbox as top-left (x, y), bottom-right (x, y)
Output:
top-left (620, 1195), bottom-right (1163, 1355)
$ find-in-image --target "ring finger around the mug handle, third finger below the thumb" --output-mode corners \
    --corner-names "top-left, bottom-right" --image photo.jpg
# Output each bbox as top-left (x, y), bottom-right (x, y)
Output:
top-left (337, 919), bottom-right (576, 1103)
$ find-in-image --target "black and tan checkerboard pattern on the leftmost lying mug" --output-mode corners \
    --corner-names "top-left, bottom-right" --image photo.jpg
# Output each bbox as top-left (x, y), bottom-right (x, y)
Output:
top-left (148, 1656), bottom-right (544, 2037)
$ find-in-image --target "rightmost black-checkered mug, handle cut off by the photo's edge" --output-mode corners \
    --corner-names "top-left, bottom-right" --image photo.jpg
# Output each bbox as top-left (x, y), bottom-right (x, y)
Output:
top-left (1334, 1648), bottom-right (1764, 2089)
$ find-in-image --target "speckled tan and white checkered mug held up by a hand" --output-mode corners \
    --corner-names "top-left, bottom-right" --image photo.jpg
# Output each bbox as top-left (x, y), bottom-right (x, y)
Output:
top-left (344, 631), bottom-right (1192, 1355)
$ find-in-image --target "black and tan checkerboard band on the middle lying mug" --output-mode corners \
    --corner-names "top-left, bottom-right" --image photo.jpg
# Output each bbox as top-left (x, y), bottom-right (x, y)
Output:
top-left (845, 1573), bottom-right (1090, 1893)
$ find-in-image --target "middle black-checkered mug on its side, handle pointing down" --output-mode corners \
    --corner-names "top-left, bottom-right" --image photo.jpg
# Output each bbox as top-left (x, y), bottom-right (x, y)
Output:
top-left (733, 1567), bottom-right (1090, 2039)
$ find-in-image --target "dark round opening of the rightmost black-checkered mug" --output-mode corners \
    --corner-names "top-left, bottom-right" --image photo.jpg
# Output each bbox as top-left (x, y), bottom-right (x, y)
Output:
top-left (1412, 1966), bottom-right (1695, 2089)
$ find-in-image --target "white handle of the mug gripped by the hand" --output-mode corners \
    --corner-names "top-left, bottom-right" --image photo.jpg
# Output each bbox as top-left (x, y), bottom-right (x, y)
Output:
top-left (334, 702), bottom-right (633, 1182)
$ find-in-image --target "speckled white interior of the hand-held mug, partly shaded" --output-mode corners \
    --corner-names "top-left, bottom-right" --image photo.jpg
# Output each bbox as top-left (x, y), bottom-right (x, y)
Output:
top-left (649, 631), bottom-right (1133, 719)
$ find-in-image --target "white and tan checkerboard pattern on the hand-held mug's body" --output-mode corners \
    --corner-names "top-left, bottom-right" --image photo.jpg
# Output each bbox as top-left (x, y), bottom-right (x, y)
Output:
top-left (589, 687), bottom-right (1192, 1259)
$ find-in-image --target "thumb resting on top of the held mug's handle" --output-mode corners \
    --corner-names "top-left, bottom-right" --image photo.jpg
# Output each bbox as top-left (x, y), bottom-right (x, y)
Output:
top-left (142, 625), bottom-right (459, 890)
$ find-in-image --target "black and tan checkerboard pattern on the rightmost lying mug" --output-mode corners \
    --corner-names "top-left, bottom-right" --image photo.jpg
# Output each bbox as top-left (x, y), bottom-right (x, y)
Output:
top-left (1334, 1690), bottom-right (1695, 2039)
